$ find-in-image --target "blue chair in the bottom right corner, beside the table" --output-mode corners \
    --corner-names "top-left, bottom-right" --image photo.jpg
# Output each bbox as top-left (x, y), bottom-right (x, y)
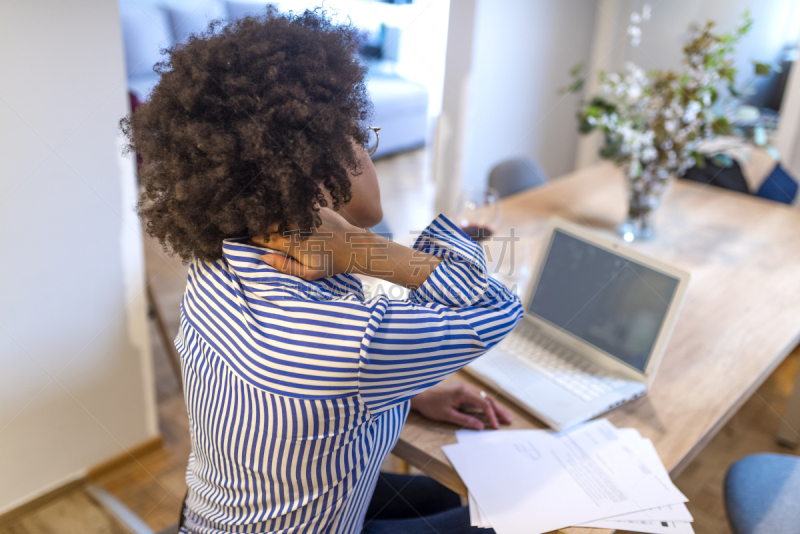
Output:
top-left (725, 454), bottom-right (800, 534)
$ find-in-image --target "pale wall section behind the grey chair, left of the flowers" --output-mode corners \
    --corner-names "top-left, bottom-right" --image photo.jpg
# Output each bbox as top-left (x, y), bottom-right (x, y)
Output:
top-left (436, 0), bottom-right (596, 212)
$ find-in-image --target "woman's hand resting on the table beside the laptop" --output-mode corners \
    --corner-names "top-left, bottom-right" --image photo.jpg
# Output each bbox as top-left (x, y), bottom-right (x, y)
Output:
top-left (411, 384), bottom-right (511, 430)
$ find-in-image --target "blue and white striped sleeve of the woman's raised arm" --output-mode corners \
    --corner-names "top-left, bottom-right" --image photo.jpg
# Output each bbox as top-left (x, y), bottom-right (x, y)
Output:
top-left (359, 215), bottom-right (523, 412)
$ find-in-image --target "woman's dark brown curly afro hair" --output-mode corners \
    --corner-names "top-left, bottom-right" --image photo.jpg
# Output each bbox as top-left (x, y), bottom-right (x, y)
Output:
top-left (120, 8), bottom-right (370, 261)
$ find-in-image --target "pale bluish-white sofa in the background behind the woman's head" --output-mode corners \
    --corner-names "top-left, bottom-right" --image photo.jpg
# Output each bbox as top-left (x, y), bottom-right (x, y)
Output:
top-left (120, 2), bottom-right (428, 158)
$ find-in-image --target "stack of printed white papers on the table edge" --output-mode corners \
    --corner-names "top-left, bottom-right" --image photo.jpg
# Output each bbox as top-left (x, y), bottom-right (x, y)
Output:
top-left (443, 419), bottom-right (694, 534)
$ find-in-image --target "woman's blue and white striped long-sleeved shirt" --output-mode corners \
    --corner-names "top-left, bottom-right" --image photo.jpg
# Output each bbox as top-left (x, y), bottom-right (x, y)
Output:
top-left (175, 215), bottom-right (522, 534)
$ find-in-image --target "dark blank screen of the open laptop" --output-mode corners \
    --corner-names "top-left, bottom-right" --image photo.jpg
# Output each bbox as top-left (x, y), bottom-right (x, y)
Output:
top-left (528, 229), bottom-right (678, 372)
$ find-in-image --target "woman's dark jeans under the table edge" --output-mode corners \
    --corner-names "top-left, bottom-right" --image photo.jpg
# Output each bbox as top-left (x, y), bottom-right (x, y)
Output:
top-left (362, 473), bottom-right (494, 534)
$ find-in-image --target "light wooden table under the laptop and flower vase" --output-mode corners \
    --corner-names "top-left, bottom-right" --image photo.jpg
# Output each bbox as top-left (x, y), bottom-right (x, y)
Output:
top-left (394, 163), bottom-right (800, 534)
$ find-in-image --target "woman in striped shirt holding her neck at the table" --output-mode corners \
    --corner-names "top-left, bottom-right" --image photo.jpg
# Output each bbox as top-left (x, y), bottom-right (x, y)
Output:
top-left (123, 10), bottom-right (521, 534)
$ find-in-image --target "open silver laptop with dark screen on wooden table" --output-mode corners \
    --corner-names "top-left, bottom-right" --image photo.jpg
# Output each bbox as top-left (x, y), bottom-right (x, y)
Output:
top-left (465, 220), bottom-right (689, 430)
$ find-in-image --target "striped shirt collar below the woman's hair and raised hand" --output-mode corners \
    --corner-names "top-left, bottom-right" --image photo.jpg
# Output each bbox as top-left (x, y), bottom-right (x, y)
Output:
top-left (222, 237), bottom-right (364, 300)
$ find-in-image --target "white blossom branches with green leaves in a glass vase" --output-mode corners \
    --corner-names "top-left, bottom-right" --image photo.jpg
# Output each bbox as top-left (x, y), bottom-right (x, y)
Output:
top-left (563, 6), bottom-right (770, 240)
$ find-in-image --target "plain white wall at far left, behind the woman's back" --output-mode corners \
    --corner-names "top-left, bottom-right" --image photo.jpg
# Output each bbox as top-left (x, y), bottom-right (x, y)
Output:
top-left (0, 0), bottom-right (157, 513)
